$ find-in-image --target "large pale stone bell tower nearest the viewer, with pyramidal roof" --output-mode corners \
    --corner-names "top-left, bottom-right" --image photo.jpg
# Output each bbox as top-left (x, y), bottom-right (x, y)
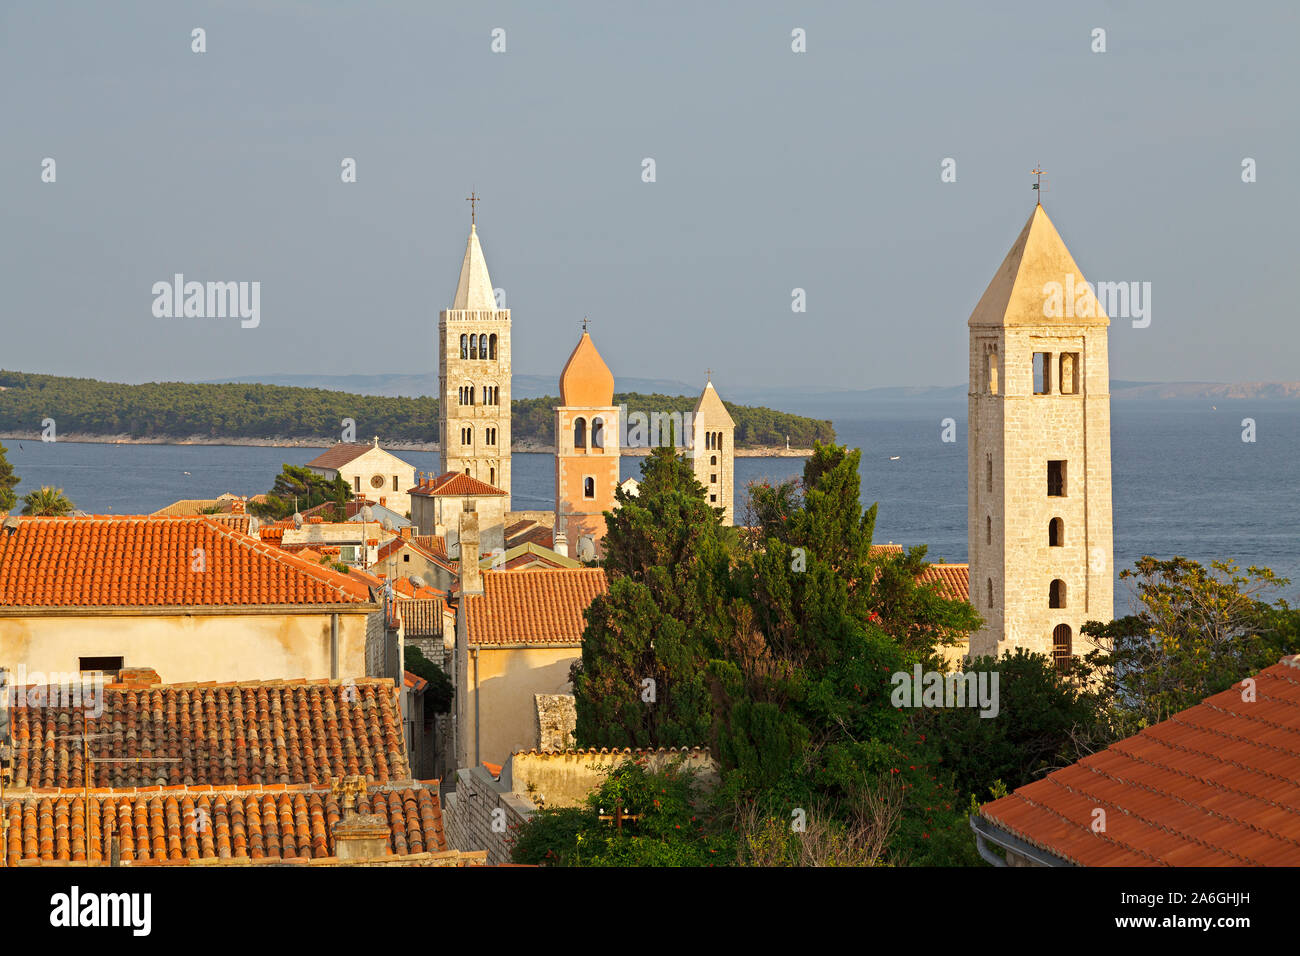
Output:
top-left (967, 206), bottom-right (1114, 662)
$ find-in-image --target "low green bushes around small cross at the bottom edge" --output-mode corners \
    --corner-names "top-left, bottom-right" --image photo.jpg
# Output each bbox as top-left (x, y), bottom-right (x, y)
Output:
top-left (511, 757), bottom-right (735, 866)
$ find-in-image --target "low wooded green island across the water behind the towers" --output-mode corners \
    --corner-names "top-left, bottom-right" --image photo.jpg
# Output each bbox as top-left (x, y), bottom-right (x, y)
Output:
top-left (0, 369), bottom-right (835, 455)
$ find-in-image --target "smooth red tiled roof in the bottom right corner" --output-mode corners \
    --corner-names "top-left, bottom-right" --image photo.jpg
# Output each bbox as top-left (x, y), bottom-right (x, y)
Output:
top-left (980, 657), bottom-right (1300, 866)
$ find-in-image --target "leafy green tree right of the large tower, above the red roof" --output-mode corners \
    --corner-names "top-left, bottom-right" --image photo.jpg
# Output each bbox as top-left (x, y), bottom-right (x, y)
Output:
top-left (1084, 557), bottom-right (1300, 736)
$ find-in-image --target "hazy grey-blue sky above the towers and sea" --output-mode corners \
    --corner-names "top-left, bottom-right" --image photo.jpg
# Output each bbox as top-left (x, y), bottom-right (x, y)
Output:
top-left (0, 0), bottom-right (1300, 393)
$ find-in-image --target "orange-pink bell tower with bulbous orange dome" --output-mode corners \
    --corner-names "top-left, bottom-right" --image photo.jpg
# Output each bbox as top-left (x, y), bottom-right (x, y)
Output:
top-left (554, 329), bottom-right (620, 561)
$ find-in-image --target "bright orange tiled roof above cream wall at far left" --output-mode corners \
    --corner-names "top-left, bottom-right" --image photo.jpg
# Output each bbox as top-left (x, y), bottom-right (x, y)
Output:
top-left (0, 515), bottom-right (369, 607)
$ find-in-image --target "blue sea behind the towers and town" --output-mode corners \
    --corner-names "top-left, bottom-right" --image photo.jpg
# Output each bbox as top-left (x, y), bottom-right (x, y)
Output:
top-left (4, 399), bottom-right (1300, 614)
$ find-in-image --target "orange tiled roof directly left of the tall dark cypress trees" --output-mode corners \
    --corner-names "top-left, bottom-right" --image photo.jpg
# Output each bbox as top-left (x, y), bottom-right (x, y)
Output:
top-left (464, 567), bottom-right (608, 645)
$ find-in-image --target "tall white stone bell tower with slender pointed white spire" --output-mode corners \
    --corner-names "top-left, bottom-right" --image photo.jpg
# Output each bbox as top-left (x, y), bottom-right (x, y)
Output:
top-left (438, 217), bottom-right (511, 511)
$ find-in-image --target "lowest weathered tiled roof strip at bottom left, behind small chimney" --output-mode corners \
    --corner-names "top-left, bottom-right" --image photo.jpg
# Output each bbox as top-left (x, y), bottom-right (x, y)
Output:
top-left (4, 786), bottom-right (447, 866)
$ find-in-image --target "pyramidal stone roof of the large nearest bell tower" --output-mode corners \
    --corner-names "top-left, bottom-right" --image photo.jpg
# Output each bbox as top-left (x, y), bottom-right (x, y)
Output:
top-left (967, 206), bottom-right (1110, 328)
